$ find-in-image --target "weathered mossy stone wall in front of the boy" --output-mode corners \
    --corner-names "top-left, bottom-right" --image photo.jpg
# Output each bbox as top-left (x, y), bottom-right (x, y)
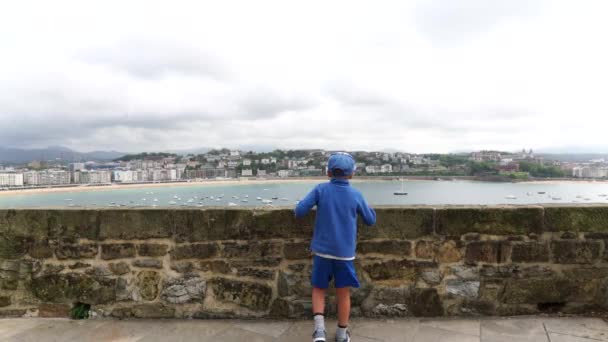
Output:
top-left (0, 206), bottom-right (608, 318)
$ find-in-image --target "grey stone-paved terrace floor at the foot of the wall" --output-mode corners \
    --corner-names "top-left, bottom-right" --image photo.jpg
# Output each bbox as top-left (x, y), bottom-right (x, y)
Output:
top-left (0, 316), bottom-right (608, 342)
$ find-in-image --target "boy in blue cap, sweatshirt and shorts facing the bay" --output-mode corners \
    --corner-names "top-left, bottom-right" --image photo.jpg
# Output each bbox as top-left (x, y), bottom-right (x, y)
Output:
top-left (295, 152), bottom-right (376, 342)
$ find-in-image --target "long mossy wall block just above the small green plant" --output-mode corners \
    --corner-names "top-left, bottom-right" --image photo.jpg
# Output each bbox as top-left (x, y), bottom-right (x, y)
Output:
top-left (30, 273), bottom-right (116, 304)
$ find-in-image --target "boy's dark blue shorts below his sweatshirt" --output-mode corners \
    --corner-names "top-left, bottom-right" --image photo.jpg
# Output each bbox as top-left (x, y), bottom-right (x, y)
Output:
top-left (310, 255), bottom-right (361, 289)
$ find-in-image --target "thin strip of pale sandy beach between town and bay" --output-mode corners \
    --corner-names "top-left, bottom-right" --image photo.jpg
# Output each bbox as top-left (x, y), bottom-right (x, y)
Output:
top-left (0, 176), bottom-right (608, 197)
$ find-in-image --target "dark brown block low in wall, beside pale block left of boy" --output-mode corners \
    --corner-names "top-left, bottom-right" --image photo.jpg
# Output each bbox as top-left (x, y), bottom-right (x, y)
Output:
top-left (209, 278), bottom-right (272, 311)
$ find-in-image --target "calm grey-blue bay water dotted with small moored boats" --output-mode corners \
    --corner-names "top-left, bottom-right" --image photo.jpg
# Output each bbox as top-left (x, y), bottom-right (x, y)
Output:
top-left (0, 180), bottom-right (608, 208)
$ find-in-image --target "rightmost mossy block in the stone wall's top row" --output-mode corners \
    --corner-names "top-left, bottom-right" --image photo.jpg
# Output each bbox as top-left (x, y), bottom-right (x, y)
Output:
top-left (545, 206), bottom-right (608, 232)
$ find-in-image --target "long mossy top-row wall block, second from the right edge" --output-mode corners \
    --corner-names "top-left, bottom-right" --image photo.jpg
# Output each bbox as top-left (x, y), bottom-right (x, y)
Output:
top-left (436, 207), bottom-right (543, 236)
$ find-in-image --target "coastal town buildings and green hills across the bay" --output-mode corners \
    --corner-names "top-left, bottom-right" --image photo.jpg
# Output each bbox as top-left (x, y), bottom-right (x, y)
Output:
top-left (0, 149), bottom-right (608, 190)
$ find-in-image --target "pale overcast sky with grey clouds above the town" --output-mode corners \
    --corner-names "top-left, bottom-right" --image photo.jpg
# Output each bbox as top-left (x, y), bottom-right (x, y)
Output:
top-left (0, 0), bottom-right (608, 152)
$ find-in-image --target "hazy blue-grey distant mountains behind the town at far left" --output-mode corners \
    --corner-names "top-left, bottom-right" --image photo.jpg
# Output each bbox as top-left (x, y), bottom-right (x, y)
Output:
top-left (0, 146), bottom-right (126, 164)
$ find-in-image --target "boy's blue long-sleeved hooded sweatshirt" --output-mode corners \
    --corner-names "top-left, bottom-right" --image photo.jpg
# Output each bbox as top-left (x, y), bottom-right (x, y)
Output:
top-left (295, 178), bottom-right (376, 258)
